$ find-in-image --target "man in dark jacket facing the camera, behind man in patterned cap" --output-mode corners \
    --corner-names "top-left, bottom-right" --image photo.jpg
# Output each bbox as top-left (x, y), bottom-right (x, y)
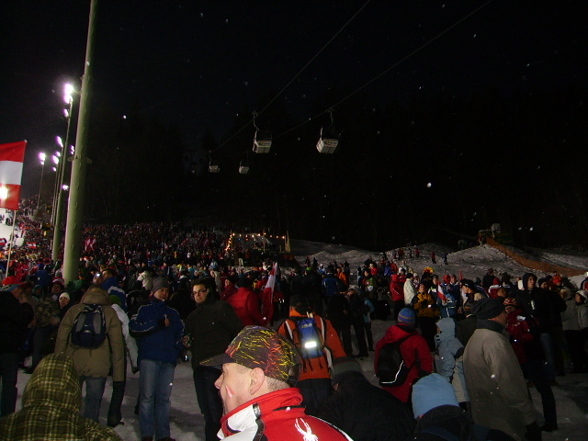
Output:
top-left (184, 278), bottom-right (243, 441)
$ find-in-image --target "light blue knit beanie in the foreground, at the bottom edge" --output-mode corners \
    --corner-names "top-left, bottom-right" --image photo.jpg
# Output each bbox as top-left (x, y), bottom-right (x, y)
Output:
top-left (412, 374), bottom-right (459, 419)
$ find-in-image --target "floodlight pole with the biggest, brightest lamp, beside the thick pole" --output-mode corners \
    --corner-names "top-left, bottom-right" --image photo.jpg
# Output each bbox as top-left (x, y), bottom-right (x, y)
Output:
top-left (51, 83), bottom-right (75, 261)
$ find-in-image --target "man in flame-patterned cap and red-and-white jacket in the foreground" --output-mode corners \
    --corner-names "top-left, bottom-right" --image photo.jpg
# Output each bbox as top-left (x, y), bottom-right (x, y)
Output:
top-left (201, 326), bottom-right (351, 441)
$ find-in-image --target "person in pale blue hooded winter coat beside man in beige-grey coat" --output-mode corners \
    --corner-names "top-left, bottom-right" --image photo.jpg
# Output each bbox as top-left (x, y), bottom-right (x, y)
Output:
top-left (435, 317), bottom-right (470, 410)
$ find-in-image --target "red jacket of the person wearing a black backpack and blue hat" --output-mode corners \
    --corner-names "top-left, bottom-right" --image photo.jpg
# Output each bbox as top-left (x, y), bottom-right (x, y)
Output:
top-left (374, 325), bottom-right (433, 403)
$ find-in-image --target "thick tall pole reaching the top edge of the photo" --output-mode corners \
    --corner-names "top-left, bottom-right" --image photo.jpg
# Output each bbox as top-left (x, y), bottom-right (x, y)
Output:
top-left (63, 0), bottom-right (98, 284)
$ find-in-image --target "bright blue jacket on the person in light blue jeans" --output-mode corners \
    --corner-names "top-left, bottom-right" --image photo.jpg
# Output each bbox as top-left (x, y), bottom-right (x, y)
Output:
top-left (129, 299), bottom-right (184, 365)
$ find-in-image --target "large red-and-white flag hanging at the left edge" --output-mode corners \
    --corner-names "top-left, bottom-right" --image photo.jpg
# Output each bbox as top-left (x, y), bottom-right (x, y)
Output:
top-left (0, 141), bottom-right (27, 210)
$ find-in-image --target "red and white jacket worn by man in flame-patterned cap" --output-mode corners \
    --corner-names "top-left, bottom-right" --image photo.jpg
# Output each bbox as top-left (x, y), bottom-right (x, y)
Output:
top-left (218, 387), bottom-right (351, 441)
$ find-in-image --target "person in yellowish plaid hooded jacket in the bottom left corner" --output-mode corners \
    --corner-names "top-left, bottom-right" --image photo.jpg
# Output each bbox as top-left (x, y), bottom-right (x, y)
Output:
top-left (0, 354), bottom-right (121, 441)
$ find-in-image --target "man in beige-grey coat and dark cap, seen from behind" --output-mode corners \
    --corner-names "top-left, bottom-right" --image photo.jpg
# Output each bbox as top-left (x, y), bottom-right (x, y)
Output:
top-left (463, 298), bottom-right (541, 441)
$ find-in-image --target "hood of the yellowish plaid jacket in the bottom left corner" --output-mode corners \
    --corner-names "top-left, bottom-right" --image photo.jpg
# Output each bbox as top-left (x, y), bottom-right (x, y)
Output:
top-left (22, 354), bottom-right (82, 413)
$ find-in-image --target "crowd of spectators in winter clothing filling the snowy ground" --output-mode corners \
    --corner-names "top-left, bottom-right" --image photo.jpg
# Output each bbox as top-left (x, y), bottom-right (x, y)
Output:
top-left (0, 216), bottom-right (588, 441)
